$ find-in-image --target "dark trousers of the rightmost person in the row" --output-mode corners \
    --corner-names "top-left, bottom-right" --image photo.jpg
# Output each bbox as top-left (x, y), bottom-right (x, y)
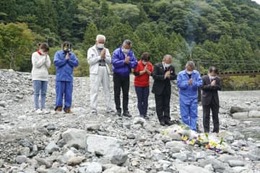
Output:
top-left (203, 99), bottom-right (219, 133)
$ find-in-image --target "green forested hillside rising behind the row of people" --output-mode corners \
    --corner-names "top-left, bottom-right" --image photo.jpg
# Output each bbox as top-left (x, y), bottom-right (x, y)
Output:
top-left (0, 0), bottom-right (260, 75)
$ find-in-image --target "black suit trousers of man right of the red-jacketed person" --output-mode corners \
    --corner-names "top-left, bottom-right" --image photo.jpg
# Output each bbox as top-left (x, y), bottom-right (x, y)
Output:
top-left (155, 91), bottom-right (171, 122)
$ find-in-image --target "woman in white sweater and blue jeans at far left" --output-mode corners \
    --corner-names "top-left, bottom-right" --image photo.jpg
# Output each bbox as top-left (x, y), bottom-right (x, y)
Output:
top-left (31, 43), bottom-right (51, 114)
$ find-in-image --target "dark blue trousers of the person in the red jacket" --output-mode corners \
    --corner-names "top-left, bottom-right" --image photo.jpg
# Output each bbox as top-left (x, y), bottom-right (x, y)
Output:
top-left (135, 86), bottom-right (150, 116)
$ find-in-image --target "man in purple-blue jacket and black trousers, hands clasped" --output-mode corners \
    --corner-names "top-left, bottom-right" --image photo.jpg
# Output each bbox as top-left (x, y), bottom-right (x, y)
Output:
top-left (112, 40), bottom-right (137, 117)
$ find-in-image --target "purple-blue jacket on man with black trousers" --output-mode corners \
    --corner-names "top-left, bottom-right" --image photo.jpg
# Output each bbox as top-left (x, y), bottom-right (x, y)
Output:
top-left (112, 47), bottom-right (137, 76)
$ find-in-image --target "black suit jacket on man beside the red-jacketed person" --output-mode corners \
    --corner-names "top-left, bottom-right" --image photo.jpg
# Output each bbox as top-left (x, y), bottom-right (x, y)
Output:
top-left (152, 63), bottom-right (176, 95)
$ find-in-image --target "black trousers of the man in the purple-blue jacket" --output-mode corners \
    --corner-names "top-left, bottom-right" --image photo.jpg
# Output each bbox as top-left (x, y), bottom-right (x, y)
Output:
top-left (113, 73), bottom-right (130, 112)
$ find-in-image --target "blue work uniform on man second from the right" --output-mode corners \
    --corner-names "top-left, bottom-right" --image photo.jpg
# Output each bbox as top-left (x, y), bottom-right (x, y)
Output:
top-left (177, 70), bottom-right (202, 131)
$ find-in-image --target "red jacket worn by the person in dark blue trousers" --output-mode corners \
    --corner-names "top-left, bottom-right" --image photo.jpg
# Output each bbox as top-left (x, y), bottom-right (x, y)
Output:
top-left (134, 60), bottom-right (153, 87)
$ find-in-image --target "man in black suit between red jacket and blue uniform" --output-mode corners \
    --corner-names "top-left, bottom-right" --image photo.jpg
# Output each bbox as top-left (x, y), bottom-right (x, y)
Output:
top-left (152, 55), bottom-right (176, 126)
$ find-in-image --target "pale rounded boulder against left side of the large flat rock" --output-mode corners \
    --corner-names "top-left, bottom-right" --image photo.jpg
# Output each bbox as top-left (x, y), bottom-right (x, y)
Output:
top-left (62, 129), bottom-right (87, 149)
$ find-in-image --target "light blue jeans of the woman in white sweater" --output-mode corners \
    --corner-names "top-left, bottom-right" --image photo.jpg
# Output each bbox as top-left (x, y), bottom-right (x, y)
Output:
top-left (33, 80), bottom-right (48, 109)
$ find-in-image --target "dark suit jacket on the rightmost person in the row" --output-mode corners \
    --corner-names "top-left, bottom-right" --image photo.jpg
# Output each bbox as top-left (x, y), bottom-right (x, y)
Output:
top-left (201, 75), bottom-right (221, 105)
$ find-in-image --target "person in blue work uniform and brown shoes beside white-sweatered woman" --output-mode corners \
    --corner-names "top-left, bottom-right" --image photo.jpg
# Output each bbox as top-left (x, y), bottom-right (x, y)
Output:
top-left (54, 41), bottom-right (78, 113)
